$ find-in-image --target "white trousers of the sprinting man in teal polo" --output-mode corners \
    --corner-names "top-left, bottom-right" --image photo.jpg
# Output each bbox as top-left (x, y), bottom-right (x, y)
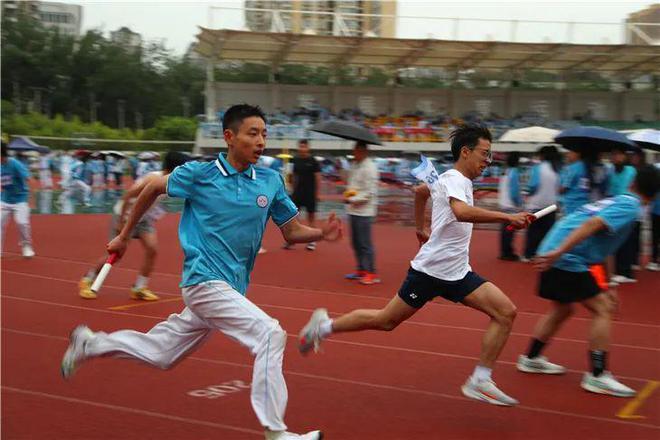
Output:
top-left (85, 281), bottom-right (288, 431)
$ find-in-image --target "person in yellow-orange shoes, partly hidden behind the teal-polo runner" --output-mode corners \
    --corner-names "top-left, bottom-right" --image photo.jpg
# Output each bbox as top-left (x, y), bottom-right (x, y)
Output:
top-left (79, 151), bottom-right (188, 301)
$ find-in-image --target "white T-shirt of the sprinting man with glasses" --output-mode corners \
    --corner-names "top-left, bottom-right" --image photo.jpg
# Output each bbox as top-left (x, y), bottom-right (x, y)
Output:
top-left (410, 169), bottom-right (474, 281)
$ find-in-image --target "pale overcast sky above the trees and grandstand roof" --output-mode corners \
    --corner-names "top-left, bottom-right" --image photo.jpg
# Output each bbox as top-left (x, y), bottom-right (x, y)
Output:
top-left (59, 0), bottom-right (653, 54)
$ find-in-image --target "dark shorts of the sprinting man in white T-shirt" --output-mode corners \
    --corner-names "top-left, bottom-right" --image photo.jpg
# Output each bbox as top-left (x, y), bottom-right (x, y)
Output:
top-left (399, 267), bottom-right (487, 309)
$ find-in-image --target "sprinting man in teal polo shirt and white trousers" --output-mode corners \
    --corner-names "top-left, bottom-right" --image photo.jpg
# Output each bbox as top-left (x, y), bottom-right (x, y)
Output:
top-left (62, 104), bottom-right (342, 440)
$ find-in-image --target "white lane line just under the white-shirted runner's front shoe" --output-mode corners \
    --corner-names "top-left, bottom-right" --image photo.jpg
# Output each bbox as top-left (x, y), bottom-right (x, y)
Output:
top-left (2, 328), bottom-right (660, 430)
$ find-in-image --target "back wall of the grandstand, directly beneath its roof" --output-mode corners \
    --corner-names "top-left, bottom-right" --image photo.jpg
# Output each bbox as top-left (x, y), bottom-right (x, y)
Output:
top-left (215, 82), bottom-right (660, 121)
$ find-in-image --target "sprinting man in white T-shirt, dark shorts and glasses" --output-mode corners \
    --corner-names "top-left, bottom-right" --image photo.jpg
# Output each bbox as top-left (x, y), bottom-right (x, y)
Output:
top-left (299, 125), bottom-right (531, 406)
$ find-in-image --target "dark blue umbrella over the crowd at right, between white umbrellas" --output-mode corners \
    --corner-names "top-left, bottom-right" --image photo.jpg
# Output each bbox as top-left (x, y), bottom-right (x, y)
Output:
top-left (555, 127), bottom-right (639, 151)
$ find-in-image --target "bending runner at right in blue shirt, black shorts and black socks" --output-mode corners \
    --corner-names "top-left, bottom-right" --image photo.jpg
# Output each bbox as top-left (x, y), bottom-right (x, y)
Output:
top-left (517, 166), bottom-right (660, 397)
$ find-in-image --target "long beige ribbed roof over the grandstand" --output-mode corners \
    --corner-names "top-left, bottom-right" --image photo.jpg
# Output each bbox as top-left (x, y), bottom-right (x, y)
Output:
top-left (196, 27), bottom-right (660, 74)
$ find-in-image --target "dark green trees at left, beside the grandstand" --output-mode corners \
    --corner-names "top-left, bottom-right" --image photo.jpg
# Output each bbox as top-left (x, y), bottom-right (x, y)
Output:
top-left (1, 12), bottom-right (205, 131)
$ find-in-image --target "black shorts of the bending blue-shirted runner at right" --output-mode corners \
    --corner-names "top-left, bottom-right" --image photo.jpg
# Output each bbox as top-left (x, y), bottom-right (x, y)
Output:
top-left (539, 267), bottom-right (602, 303)
